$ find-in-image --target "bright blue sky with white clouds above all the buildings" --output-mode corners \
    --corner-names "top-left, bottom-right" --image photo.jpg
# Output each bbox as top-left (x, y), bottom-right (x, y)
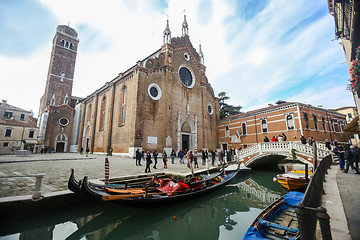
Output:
top-left (0, 0), bottom-right (355, 117)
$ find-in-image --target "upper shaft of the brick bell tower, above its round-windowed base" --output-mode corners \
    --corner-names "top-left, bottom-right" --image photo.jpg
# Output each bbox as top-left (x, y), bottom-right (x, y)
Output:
top-left (39, 25), bottom-right (79, 113)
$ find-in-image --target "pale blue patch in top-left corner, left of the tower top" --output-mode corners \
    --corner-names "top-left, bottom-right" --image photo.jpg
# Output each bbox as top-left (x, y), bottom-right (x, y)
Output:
top-left (0, 0), bottom-right (56, 57)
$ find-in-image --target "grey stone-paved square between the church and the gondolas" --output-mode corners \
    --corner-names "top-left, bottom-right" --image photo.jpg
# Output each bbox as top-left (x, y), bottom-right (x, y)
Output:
top-left (0, 153), bottom-right (211, 198)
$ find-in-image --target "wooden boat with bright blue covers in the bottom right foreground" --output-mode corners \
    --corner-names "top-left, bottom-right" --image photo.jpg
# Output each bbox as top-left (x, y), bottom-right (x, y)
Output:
top-left (243, 191), bottom-right (304, 240)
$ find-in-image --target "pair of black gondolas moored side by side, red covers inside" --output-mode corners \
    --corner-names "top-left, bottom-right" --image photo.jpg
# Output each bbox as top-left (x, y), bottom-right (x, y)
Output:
top-left (68, 166), bottom-right (239, 207)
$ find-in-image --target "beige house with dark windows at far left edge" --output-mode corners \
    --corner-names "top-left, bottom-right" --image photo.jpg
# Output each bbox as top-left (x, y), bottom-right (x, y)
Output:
top-left (0, 100), bottom-right (39, 154)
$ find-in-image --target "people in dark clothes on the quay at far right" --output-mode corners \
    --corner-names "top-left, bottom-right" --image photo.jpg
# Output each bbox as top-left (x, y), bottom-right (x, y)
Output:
top-left (333, 143), bottom-right (360, 174)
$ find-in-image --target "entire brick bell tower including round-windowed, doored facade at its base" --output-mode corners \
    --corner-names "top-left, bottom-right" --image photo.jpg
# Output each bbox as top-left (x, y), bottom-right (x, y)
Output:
top-left (38, 25), bottom-right (81, 152)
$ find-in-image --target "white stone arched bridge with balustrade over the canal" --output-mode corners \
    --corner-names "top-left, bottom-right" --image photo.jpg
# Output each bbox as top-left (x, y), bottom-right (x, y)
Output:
top-left (239, 142), bottom-right (332, 167)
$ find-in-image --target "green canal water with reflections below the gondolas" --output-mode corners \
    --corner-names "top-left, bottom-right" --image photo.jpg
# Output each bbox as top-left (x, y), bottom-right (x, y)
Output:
top-left (0, 171), bottom-right (284, 240)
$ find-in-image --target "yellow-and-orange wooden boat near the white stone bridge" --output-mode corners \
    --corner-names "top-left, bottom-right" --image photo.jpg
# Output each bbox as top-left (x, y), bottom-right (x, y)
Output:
top-left (273, 164), bottom-right (313, 191)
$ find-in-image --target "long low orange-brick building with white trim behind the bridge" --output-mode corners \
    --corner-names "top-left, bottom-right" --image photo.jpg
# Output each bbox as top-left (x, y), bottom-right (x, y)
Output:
top-left (219, 101), bottom-right (349, 149)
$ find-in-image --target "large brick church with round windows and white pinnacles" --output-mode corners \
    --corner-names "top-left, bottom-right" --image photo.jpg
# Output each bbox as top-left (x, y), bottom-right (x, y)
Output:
top-left (79, 16), bottom-right (219, 155)
